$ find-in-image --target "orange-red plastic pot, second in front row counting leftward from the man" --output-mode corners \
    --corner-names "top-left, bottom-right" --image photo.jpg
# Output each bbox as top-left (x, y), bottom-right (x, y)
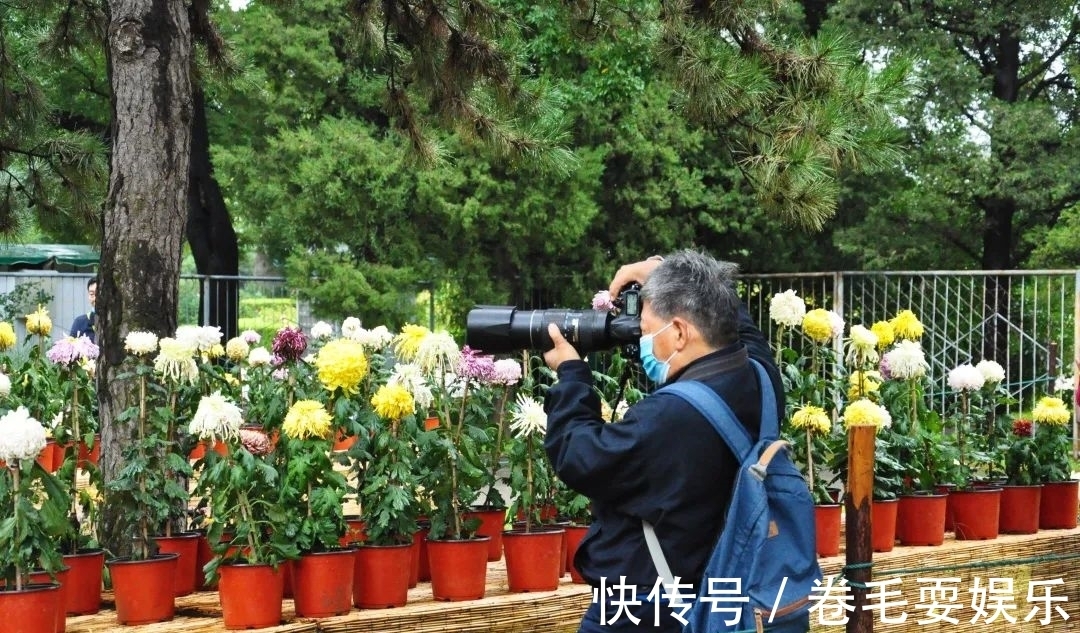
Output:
top-left (428, 537), bottom-right (489, 602)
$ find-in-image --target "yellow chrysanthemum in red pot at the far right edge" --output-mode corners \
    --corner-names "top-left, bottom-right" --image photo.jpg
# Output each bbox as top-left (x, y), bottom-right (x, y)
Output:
top-left (1031, 395), bottom-right (1080, 529)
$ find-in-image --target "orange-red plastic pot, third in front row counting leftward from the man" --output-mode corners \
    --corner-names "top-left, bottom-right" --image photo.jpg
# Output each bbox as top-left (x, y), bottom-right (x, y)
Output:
top-left (352, 543), bottom-right (413, 609)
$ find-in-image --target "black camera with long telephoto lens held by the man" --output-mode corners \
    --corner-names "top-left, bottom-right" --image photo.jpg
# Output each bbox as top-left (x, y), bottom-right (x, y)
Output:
top-left (465, 283), bottom-right (642, 352)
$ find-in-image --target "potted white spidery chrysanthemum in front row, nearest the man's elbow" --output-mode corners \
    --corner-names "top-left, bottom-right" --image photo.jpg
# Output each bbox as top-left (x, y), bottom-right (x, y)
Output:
top-left (502, 392), bottom-right (566, 592)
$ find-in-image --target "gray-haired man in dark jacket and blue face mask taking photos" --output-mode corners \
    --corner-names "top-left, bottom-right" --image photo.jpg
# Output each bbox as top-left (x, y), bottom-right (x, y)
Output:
top-left (544, 251), bottom-right (784, 633)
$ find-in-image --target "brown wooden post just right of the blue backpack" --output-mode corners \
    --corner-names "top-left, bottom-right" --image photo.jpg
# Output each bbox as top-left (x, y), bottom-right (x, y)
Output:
top-left (843, 426), bottom-right (877, 633)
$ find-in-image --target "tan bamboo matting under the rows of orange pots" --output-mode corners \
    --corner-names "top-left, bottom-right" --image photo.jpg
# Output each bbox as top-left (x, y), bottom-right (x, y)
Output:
top-left (61, 528), bottom-right (1080, 633)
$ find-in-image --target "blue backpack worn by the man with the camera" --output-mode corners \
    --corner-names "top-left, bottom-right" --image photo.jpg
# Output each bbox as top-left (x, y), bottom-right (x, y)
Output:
top-left (643, 360), bottom-right (822, 633)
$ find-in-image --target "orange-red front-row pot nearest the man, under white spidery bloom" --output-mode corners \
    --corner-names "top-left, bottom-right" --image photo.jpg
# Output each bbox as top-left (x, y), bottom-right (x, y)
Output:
top-left (502, 528), bottom-right (566, 593)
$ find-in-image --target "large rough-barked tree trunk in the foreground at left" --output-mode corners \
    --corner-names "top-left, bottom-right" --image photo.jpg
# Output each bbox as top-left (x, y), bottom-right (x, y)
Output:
top-left (97, 0), bottom-right (192, 554)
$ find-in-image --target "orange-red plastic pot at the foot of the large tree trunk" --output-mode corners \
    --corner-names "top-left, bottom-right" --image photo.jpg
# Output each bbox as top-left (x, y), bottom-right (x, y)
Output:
top-left (106, 554), bottom-right (179, 624)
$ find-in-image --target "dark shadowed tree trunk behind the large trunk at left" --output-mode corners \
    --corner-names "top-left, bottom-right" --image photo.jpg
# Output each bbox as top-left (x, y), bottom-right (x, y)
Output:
top-left (187, 85), bottom-right (240, 340)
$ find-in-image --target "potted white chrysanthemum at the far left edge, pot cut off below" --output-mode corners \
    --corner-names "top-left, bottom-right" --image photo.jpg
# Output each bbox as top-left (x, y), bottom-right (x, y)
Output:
top-left (0, 406), bottom-right (67, 633)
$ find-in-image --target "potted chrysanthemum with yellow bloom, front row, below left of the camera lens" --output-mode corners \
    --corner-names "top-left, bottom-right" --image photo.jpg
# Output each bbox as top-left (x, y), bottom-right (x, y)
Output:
top-left (353, 381), bottom-right (419, 608)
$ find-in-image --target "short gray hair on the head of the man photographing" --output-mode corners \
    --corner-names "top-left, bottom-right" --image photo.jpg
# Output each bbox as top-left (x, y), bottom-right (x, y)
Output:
top-left (642, 250), bottom-right (741, 347)
